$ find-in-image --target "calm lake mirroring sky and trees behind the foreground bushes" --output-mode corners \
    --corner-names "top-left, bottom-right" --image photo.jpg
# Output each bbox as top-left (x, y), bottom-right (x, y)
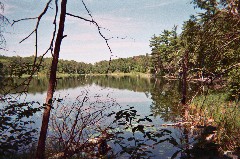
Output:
top-left (0, 76), bottom-right (221, 159)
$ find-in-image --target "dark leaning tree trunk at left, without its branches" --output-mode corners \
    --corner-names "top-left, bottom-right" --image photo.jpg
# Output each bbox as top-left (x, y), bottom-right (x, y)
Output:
top-left (35, 0), bottom-right (67, 159)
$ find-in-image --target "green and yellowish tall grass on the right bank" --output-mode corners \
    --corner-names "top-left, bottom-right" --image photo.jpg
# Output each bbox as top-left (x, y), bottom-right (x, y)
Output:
top-left (190, 92), bottom-right (240, 152)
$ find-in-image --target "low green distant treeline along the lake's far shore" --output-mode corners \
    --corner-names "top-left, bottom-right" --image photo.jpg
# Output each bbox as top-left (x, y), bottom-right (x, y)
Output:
top-left (0, 54), bottom-right (151, 77)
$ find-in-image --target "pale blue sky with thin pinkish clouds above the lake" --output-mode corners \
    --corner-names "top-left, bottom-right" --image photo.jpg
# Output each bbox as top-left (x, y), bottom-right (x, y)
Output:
top-left (0, 0), bottom-right (197, 63)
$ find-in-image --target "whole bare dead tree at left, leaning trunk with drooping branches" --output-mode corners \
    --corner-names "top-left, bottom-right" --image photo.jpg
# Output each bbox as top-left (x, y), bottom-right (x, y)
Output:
top-left (6, 0), bottom-right (142, 159)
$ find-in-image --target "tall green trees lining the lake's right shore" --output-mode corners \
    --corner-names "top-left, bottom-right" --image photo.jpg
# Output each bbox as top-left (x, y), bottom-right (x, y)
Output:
top-left (150, 0), bottom-right (240, 77)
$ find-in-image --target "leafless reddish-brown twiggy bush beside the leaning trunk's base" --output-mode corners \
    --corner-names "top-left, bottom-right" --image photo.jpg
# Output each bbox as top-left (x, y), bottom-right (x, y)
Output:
top-left (48, 89), bottom-right (118, 158)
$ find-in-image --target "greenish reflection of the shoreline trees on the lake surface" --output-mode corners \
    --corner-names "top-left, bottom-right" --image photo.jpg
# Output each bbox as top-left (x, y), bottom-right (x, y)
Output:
top-left (0, 76), bottom-right (198, 122)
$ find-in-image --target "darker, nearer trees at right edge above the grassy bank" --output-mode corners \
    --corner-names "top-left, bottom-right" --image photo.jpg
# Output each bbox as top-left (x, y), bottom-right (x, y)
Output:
top-left (185, 0), bottom-right (240, 101)
